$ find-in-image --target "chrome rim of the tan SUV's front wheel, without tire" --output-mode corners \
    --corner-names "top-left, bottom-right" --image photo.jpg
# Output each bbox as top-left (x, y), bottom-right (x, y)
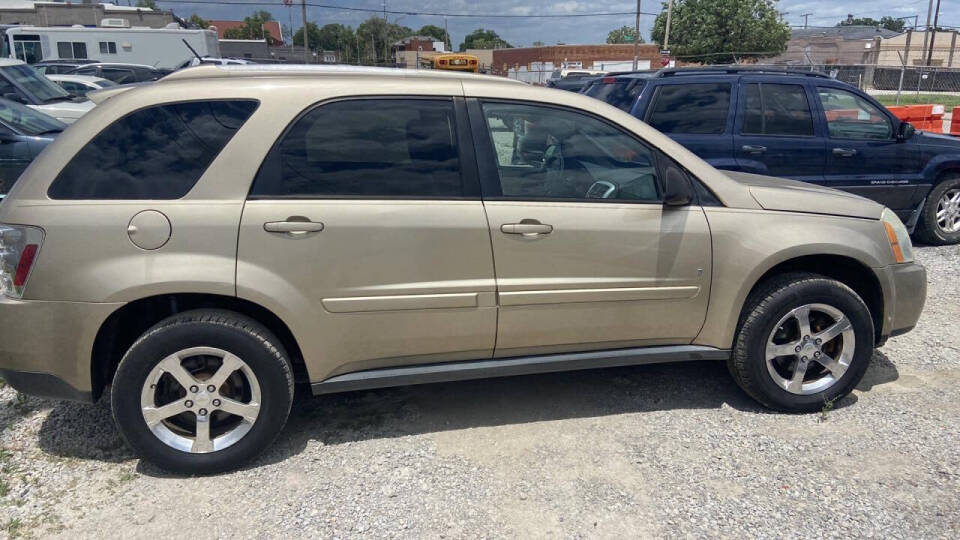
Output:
top-left (766, 304), bottom-right (856, 395)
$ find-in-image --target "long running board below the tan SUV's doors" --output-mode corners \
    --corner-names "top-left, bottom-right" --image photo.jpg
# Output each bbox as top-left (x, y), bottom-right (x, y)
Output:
top-left (310, 345), bottom-right (730, 395)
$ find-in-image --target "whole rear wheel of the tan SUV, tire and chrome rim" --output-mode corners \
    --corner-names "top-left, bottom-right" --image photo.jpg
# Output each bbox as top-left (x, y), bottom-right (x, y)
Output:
top-left (111, 310), bottom-right (293, 474)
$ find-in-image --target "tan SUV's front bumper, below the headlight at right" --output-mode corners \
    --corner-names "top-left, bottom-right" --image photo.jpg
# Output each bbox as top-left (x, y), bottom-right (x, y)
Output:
top-left (877, 263), bottom-right (927, 343)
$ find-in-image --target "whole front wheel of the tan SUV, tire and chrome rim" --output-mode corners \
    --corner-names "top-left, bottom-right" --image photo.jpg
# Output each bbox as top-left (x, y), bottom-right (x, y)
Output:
top-left (728, 274), bottom-right (874, 412)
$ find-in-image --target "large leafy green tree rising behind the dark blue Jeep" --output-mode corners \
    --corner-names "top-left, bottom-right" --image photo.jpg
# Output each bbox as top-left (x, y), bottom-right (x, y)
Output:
top-left (651, 0), bottom-right (790, 64)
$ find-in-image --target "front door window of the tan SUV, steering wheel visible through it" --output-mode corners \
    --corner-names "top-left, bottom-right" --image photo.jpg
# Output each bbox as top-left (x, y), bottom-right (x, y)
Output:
top-left (483, 103), bottom-right (661, 203)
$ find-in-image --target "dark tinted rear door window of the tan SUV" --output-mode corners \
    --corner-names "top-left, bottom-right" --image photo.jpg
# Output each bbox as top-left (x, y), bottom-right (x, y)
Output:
top-left (250, 99), bottom-right (463, 198)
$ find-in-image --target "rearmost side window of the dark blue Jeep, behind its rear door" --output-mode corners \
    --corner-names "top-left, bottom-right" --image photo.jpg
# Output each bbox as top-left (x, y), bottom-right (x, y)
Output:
top-left (646, 83), bottom-right (730, 135)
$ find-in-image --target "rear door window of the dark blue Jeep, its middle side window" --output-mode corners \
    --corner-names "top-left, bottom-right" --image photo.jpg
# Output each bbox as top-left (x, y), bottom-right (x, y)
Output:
top-left (743, 83), bottom-right (813, 137)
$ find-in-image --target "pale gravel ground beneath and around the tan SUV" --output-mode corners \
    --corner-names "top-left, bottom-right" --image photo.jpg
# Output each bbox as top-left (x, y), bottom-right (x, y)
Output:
top-left (0, 247), bottom-right (960, 538)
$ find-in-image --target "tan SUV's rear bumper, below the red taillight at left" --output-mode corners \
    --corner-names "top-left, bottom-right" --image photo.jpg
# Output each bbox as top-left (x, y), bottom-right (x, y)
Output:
top-left (0, 296), bottom-right (123, 401)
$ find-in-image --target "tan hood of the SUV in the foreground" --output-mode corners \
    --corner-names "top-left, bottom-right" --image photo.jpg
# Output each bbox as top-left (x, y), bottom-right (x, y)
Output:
top-left (723, 171), bottom-right (883, 219)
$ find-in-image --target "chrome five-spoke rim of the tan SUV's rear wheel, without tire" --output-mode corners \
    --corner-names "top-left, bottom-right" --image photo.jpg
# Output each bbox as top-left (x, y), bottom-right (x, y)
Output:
top-left (140, 347), bottom-right (261, 453)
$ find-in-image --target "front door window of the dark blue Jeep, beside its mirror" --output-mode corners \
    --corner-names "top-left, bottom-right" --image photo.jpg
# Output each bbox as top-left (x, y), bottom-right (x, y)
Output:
top-left (817, 87), bottom-right (893, 140)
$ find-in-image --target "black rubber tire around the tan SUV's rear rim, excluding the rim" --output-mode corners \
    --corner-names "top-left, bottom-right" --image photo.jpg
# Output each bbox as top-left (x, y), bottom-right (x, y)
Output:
top-left (111, 310), bottom-right (293, 474)
